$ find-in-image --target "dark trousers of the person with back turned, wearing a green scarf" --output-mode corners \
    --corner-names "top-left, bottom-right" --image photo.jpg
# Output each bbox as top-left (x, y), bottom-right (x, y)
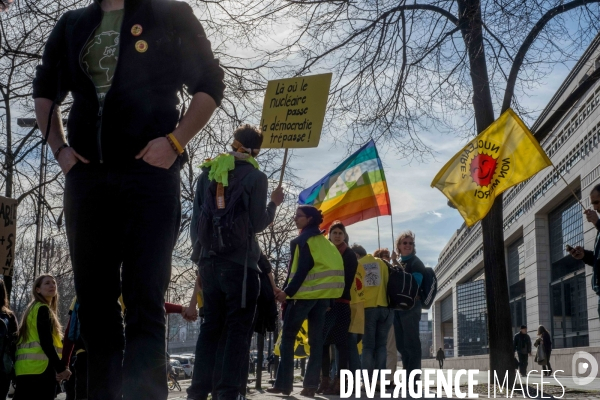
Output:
top-left (187, 257), bottom-right (260, 400)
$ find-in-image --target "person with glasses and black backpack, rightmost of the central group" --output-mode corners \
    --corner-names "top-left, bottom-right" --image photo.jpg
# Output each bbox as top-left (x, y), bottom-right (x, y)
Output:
top-left (394, 231), bottom-right (425, 390)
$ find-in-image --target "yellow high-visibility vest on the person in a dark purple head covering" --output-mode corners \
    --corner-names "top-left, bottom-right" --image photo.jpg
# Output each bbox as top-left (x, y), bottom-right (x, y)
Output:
top-left (288, 235), bottom-right (344, 300)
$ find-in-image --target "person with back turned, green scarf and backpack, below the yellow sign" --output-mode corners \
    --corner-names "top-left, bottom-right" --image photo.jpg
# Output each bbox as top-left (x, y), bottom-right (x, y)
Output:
top-left (187, 125), bottom-right (283, 400)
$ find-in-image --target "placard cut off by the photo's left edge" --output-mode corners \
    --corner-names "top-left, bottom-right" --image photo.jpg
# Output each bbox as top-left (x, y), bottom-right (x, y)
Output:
top-left (0, 196), bottom-right (17, 276)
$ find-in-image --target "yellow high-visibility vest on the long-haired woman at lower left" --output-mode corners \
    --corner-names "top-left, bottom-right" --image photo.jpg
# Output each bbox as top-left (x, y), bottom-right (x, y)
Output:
top-left (15, 301), bottom-right (62, 376)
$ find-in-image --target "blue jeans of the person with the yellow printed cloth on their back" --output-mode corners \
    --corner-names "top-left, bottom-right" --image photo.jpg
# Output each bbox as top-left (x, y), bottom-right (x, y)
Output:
top-left (362, 307), bottom-right (394, 376)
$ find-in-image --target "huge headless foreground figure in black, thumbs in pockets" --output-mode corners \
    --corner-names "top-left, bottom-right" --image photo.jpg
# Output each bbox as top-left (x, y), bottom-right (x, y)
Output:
top-left (33, 0), bottom-right (225, 400)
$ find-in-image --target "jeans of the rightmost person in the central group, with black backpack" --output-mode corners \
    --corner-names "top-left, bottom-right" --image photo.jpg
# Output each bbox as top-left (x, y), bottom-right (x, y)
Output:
top-left (394, 300), bottom-right (421, 379)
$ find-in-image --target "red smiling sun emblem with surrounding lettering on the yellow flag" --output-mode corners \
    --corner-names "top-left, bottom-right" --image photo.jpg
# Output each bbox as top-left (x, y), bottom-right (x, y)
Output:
top-left (460, 140), bottom-right (511, 200)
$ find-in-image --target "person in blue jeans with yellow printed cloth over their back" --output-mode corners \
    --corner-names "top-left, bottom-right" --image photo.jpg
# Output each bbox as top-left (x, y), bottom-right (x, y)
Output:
top-left (352, 244), bottom-right (394, 376)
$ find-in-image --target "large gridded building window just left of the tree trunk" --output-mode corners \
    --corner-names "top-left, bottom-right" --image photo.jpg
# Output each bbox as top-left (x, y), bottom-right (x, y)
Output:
top-left (456, 280), bottom-right (489, 357)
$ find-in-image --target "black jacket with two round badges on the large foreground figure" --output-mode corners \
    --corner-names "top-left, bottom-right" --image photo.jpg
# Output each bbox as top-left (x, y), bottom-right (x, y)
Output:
top-left (33, 0), bottom-right (225, 164)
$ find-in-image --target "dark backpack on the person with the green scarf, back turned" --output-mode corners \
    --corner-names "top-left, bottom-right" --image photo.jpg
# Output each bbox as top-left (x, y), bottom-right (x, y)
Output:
top-left (196, 163), bottom-right (254, 255)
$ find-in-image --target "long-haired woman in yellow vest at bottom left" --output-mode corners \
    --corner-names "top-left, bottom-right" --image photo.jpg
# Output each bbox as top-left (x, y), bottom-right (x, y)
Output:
top-left (14, 275), bottom-right (71, 400)
